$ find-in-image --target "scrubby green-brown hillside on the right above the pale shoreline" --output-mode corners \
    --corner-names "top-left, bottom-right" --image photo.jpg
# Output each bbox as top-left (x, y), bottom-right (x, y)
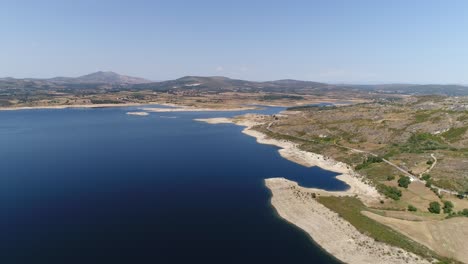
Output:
top-left (258, 96), bottom-right (468, 193)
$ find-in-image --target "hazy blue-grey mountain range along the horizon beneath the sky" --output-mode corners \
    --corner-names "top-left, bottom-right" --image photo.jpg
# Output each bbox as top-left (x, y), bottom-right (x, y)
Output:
top-left (0, 71), bottom-right (468, 96)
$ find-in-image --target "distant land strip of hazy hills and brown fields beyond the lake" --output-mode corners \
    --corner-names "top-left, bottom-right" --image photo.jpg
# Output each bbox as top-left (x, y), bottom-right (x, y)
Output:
top-left (0, 71), bottom-right (468, 107)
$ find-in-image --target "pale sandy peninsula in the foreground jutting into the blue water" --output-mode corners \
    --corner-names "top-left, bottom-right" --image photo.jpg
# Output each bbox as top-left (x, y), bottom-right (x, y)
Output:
top-left (265, 178), bottom-right (429, 264)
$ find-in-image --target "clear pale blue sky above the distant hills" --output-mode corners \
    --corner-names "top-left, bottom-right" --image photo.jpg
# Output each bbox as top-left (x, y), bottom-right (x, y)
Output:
top-left (0, 0), bottom-right (468, 84)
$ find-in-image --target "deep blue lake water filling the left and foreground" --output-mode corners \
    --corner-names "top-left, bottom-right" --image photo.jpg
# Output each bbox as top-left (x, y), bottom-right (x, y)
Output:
top-left (0, 108), bottom-right (346, 264)
